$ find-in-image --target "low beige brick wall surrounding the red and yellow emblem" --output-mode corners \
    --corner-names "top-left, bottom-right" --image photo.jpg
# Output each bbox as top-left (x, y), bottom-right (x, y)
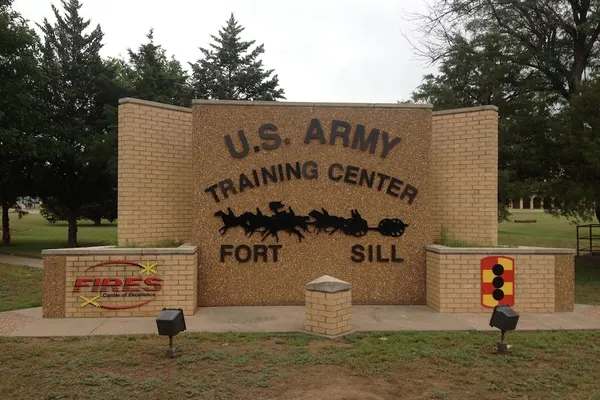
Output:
top-left (427, 247), bottom-right (574, 313)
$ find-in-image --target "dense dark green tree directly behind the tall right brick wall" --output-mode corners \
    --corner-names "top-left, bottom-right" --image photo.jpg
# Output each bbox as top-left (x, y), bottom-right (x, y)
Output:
top-left (412, 32), bottom-right (553, 220)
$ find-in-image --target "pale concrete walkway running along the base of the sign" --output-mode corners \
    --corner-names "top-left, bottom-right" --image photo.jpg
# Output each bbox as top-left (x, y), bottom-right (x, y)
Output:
top-left (0, 305), bottom-right (600, 337)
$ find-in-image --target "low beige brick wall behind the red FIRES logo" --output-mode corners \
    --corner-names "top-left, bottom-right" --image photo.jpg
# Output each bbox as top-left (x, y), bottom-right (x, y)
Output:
top-left (43, 247), bottom-right (198, 318)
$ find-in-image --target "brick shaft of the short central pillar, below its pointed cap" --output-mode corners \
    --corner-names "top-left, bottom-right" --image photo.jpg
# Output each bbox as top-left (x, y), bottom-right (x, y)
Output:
top-left (304, 290), bottom-right (352, 336)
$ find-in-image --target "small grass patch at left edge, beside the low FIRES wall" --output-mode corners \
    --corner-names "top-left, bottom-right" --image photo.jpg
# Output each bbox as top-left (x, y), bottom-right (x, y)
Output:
top-left (0, 264), bottom-right (42, 312)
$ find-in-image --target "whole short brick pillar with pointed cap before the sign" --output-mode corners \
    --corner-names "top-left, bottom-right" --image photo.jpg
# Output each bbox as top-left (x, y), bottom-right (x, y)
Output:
top-left (304, 275), bottom-right (352, 336)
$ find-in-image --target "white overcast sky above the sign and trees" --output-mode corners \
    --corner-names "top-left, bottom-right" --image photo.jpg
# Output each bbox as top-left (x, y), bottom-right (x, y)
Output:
top-left (13, 0), bottom-right (435, 103)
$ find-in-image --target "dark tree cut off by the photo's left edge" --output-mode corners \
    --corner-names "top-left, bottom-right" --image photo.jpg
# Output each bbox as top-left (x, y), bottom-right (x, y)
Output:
top-left (0, 0), bottom-right (40, 245)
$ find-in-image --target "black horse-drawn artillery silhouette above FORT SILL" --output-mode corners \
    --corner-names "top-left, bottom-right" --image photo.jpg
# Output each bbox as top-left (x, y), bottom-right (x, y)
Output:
top-left (215, 201), bottom-right (408, 242)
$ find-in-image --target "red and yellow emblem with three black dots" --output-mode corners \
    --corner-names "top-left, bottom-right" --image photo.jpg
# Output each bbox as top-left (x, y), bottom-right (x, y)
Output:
top-left (481, 256), bottom-right (515, 308)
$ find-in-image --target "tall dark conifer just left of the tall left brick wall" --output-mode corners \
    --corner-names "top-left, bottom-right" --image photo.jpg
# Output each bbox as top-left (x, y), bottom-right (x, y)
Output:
top-left (40, 0), bottom-right (120, 247)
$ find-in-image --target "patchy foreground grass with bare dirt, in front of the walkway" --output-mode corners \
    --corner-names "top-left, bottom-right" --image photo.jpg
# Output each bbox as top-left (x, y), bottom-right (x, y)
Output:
top-left (0, 331), bottom-right (600, 400)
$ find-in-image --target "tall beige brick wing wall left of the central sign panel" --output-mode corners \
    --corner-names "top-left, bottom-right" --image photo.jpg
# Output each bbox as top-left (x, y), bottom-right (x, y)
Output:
top-left (118, 99), bottom-right (192, 245)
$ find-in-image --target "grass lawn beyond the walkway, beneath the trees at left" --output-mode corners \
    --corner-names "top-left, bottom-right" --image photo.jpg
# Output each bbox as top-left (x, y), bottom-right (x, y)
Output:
top-left (0, 214), bottom-right (117, 258)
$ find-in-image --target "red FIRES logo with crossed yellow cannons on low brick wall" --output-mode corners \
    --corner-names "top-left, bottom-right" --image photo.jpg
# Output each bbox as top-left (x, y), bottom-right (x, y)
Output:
top-left (73, 260), bottom-right (163, 310)
